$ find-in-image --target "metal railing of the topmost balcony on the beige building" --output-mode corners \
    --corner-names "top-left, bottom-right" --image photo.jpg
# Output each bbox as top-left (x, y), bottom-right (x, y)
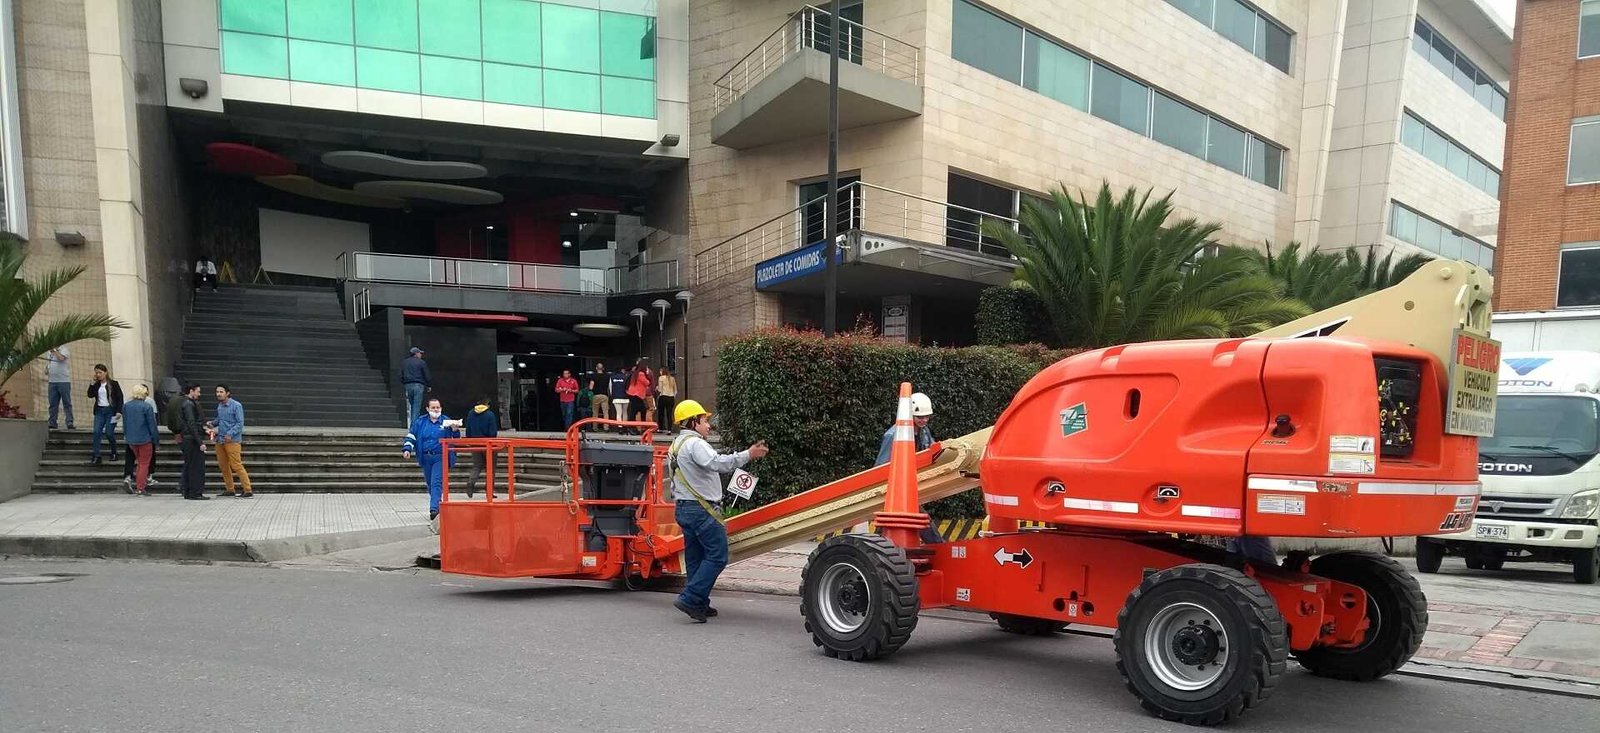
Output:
top-left (715, 5), bottom-right (922, 112)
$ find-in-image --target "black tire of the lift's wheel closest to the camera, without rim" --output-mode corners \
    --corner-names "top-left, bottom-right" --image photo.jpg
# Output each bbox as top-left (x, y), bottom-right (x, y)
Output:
top-left (1112, 565), bottom-right (1290, 725)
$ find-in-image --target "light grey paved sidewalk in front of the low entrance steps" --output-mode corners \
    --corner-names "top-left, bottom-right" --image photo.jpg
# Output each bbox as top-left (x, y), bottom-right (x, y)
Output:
top-left (0, 491), bottom-right (430, 562)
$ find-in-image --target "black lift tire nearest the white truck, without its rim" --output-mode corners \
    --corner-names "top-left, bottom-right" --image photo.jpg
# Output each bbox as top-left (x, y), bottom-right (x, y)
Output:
top-left (1294, 552), bottom-right (1427, 682)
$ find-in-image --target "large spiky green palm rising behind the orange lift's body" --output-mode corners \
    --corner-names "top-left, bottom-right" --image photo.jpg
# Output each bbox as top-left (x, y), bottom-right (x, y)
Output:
top-left (984, 184), bottom-right (1309, 347)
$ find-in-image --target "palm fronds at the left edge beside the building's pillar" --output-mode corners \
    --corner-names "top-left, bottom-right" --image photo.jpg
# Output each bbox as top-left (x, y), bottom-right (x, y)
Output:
top-left (0, 232), bottom-right (128, 395)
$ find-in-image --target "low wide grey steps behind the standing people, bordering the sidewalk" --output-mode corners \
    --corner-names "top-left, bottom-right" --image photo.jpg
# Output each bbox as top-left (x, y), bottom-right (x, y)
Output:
top-left (34, 428), bottom-right (563, 499)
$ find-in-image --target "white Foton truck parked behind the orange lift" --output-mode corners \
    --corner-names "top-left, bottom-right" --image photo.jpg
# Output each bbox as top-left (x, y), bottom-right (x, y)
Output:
top-left (1416, 342), bottom-right (1600, 584)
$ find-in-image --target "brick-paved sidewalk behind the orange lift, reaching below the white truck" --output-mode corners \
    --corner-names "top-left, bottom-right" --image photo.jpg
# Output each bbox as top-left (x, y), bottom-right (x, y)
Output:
top-left (717, 543), bottom-right (1600, 691)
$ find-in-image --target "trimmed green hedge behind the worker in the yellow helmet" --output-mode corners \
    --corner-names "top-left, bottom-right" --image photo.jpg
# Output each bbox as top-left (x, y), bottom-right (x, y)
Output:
top-left (717, 330), bottom-right (1072, 517)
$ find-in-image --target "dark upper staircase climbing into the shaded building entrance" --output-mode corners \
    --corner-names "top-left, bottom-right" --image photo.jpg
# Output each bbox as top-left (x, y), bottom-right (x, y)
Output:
top-left (174, 285), bottom-right (405, 434)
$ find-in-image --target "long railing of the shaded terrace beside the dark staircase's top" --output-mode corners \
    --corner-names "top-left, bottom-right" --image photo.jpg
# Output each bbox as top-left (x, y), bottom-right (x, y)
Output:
top-left (339, 251), bottom-right (680, 296)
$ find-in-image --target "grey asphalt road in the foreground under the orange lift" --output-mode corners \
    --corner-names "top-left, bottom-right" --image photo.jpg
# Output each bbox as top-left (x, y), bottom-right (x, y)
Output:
top-left (0, 560), bottom-right (1600, 733)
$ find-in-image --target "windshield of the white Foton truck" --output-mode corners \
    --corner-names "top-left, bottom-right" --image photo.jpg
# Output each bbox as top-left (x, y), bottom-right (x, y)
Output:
top-left (1478, 394), bottom-right (1600, 463)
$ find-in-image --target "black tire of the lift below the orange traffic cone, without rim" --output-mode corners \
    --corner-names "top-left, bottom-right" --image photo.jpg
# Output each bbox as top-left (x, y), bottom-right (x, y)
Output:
top-left (800, 535), bottom-right (922, 661)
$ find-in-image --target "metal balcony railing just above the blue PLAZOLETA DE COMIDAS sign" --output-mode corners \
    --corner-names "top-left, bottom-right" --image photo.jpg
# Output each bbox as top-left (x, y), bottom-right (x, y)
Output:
top-left (694, 182), bottom-right (1018, 285)
